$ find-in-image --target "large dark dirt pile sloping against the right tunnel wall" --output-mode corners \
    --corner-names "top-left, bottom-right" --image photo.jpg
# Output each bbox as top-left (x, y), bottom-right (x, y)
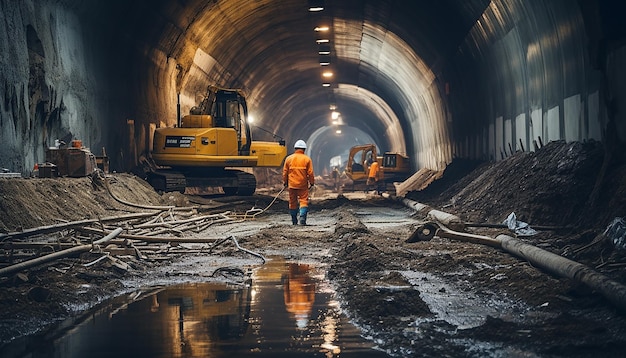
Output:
top-left (408, 141), bottom-right (626, 229)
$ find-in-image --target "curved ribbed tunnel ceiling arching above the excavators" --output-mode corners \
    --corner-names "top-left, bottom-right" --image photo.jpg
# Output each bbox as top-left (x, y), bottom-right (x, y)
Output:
top-left (114, 0), bottom-right (489, 171)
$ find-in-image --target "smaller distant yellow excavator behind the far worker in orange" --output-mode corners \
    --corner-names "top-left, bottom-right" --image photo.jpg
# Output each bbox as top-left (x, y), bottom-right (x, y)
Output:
top-left (345, 144), bottom-right (411, 190)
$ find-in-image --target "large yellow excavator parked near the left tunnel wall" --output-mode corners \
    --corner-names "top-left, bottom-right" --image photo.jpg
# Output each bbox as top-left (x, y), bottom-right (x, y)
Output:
top-left (147, 86), bottom-right (287, 195)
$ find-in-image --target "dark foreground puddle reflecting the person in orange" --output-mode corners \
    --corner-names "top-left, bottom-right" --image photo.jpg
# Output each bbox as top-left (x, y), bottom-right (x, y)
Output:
top-left (0, 260), bottom-right (386, 358)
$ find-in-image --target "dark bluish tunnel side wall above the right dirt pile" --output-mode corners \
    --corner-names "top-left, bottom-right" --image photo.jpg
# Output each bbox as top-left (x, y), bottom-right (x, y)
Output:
top-left (448, 1), bottom-right (626, 160)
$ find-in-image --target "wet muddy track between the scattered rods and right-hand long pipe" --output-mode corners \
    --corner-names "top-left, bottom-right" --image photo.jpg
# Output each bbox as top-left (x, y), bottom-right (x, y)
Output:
top-left (4, 190), bottom-right (626, 356)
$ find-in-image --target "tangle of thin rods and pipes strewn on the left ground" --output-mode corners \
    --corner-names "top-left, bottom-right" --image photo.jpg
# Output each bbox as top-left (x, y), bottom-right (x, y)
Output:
top-left (0, 180), bottom-right (284, 276)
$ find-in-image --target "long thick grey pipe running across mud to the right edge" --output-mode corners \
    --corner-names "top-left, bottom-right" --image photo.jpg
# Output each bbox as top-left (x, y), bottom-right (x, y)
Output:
top-left (405, 199), bottom-right (626, 313)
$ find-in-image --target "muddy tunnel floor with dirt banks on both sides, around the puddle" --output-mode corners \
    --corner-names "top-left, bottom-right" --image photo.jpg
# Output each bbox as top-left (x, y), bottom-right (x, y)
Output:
top-left (0, 142), bottom-right (626, 357)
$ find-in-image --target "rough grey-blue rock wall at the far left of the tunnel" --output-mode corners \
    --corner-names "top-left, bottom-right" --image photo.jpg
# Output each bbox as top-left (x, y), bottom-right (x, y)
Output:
top-left (0, 0), bottom-right (108, 174)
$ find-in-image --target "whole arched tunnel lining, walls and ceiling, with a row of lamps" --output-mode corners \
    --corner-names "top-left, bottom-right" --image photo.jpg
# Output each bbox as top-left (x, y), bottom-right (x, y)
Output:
top-left (0, 0), bottom-right (626, 178)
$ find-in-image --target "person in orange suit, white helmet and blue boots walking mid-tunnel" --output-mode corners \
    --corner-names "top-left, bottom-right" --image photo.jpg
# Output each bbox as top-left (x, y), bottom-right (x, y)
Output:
top-left (283, 139), bottom-right (315, 225)
